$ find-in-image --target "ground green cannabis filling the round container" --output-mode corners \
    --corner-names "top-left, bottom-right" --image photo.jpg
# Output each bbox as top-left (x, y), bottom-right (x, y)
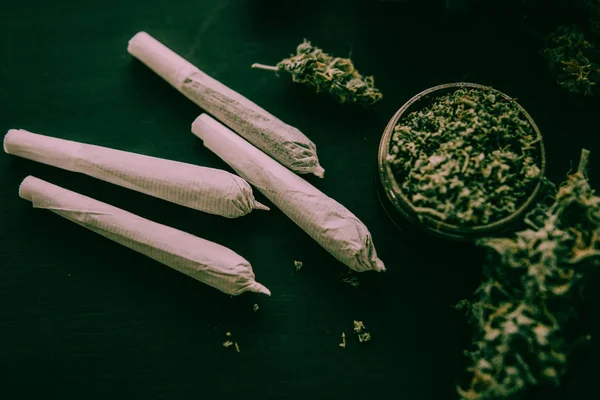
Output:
top-left (386, 88), bottom-right (542, 227)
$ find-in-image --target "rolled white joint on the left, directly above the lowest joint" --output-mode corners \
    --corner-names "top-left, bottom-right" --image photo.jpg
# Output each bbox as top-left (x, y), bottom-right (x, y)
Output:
top-left (4, 129), bottom-right (269, 218)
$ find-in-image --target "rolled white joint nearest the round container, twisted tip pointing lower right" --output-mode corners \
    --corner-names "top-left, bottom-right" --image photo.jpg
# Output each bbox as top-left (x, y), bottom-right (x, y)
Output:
top-left (192, 114), bottom-right (385, 272)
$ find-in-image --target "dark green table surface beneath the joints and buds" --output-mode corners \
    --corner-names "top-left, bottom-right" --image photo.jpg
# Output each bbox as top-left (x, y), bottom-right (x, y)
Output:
top-left (0, 0), bottom-right (600, 400)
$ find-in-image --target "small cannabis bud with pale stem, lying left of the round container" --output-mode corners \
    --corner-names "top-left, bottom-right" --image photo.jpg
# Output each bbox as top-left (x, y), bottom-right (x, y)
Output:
top-left (252, 40), bottom-right (383, 106)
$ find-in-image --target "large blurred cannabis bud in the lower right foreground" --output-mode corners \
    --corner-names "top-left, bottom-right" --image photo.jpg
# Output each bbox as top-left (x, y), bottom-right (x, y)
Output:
top-left (459, 150), bottom-right (600, 400)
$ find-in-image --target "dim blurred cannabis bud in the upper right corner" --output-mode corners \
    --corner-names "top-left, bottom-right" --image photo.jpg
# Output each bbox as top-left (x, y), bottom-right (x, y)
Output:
top-left (542, 25), bottom-right (600, 96)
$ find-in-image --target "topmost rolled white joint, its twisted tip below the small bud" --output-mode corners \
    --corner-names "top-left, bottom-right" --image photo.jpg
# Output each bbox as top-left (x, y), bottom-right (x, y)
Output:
top-left (127, 32), bottom-right (325, 178)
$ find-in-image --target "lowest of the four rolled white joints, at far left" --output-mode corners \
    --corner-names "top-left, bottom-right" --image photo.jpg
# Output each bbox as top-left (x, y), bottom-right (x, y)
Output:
top-left (19, 176), bottom-right (271, 295)
